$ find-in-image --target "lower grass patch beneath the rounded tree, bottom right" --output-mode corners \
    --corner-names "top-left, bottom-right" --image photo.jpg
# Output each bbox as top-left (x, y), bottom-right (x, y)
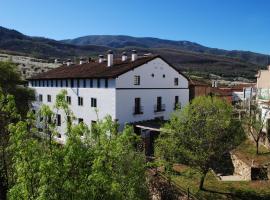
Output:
top-left (171, 165), bottom-right (270, 200)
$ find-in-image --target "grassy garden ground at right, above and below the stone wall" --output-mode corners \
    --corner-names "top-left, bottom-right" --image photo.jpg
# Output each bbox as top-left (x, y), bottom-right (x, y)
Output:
top-left (167, 140), bottom-right (270, 200)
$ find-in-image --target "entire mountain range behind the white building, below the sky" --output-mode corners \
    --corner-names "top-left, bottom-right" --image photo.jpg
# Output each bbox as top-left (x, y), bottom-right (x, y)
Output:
top-left (0, 26), bottom-right (270, 79)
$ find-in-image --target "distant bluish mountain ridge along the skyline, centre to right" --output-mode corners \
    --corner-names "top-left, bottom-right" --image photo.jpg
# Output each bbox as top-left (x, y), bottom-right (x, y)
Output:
top-left (62, 35), bottom-right (270, 65)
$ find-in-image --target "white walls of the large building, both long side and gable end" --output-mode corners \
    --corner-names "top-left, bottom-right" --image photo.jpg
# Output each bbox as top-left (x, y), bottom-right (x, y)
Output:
top-left (29, 58), bottom-right (189, 137)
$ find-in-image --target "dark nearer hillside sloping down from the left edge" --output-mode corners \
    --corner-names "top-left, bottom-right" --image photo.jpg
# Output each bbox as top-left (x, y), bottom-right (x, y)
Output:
top-left (0, 26), bottom-right (108, 58)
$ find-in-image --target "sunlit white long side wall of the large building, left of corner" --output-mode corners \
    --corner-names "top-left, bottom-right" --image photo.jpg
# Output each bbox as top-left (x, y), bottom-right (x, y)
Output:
top-left (30, 79), bottom-right (115, 141)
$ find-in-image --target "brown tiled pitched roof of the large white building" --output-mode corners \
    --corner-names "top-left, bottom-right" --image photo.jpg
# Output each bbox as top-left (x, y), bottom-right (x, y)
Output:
top-left (28, 55), bottom-right (188, 80)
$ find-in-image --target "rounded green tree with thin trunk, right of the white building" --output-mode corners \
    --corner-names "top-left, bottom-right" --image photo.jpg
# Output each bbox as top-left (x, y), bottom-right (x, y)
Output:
top-left (157, 96), bottom-right (244, 189)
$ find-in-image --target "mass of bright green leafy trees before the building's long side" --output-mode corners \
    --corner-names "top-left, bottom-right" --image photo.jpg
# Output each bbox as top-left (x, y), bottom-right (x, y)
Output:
top-left (9, 91), bottom-right (147, 200)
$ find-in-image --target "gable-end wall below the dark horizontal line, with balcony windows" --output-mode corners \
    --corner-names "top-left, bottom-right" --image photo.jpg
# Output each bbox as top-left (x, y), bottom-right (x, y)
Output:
top-left (116, 89), bottom-right (189, 128)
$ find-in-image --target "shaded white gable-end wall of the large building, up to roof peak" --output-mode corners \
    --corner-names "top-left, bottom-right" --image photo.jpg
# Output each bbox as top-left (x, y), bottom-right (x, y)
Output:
top-left (116, 58), bottom-right (189, 125)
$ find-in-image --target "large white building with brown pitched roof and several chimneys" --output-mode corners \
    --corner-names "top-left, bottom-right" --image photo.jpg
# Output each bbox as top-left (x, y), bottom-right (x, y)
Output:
top-left (26, 51), bottom-right (189, 142)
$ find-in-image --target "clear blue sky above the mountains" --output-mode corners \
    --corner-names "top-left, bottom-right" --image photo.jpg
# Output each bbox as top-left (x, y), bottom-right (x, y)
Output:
top-left (0, 0), bottom-right (270, 54)
